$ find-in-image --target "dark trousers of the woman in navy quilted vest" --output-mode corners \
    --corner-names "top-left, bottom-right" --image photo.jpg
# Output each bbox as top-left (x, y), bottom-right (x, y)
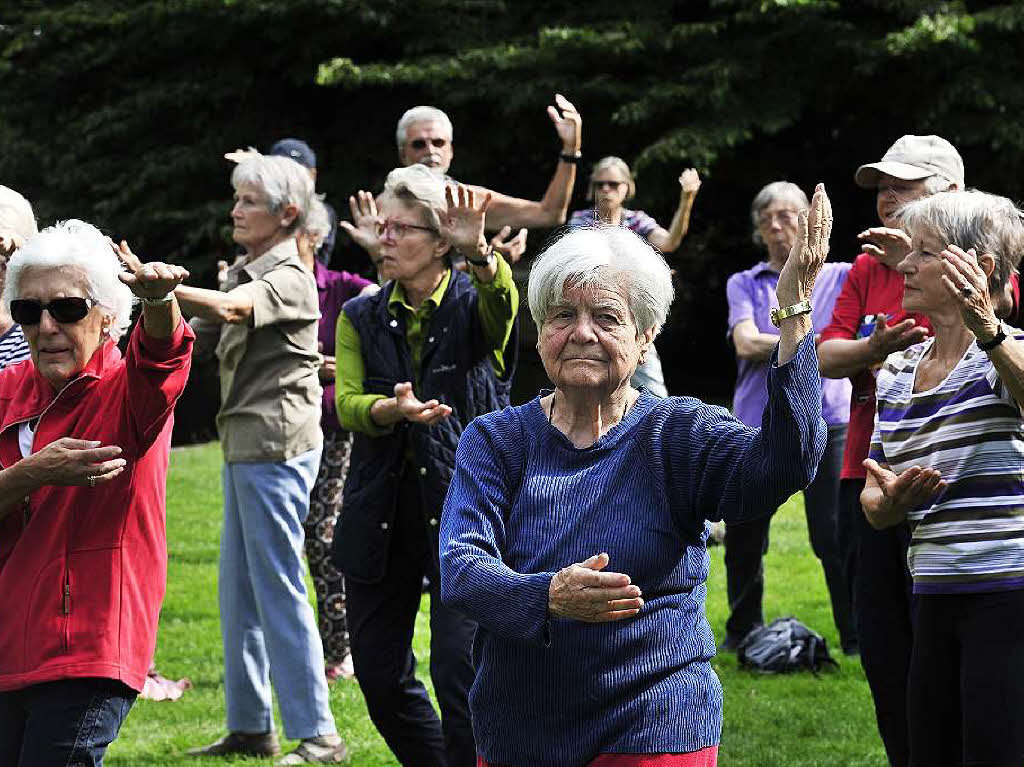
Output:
top-left (345, 474), bottom-right (476, 767)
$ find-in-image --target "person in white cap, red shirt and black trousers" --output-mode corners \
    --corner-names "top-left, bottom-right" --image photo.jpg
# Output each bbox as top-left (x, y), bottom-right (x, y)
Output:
top-left (818, 135), bottom-right (964, 766)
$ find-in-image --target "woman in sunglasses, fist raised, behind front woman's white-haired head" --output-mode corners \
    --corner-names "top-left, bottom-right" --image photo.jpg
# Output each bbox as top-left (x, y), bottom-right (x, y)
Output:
top-left (569, 157), bottom-right (700, 396)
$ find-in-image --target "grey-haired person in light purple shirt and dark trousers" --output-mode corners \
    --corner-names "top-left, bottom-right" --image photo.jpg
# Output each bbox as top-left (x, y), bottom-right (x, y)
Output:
top-left (723, 181), bottom-right (857, 654)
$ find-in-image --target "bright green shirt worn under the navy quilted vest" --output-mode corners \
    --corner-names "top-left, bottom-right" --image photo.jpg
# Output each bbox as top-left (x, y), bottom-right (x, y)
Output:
top-left (335, 254), bottom-right (519, 436)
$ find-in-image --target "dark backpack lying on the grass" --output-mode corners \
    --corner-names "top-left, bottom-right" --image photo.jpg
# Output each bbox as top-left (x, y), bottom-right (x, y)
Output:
top-left (736, 617), bottom-right (839, 674)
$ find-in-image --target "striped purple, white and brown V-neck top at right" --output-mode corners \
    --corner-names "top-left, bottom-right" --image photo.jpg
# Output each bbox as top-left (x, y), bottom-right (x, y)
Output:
top-left (869, 330), bottom-right (1024, 594)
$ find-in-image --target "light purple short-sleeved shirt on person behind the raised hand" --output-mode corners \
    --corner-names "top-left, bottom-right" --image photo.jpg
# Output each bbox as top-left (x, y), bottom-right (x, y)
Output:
top-left (725, 261), bottom-right (851, 426)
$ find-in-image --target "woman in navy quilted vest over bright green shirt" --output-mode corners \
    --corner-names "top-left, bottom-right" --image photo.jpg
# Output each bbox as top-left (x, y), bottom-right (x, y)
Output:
top-left (334, 165), bottom-right (518, 767)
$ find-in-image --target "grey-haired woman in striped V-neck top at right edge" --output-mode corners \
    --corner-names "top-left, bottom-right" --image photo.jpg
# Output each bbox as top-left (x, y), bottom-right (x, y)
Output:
top-left (860, 191), bottom-right (1024, 766)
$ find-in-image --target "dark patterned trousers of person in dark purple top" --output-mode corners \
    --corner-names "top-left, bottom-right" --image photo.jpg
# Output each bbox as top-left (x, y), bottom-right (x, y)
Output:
top-left (303, 431), bottom-right (352, 665)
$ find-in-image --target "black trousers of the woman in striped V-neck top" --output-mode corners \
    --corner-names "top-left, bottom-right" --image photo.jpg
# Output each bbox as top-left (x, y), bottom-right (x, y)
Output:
top-left (907, 590), bottom-right (1024, 767)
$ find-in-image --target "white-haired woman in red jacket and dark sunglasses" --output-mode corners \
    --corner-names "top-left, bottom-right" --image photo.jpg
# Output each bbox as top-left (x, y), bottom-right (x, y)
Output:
top-left (0, 221), bottom-right (194, 767)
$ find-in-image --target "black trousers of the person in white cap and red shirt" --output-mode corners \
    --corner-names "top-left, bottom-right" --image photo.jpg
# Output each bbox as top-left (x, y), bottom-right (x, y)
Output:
top-left (840, 479), bottom-right (913, 767)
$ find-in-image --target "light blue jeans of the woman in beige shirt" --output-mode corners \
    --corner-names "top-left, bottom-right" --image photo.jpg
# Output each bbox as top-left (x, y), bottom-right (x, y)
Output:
top-left (218, 449), bottom-right (337, 739)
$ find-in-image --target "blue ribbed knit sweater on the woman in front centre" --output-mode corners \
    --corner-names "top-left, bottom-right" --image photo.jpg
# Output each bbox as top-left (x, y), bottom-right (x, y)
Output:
top-left (440, 335), bottom-right (826, 767)
